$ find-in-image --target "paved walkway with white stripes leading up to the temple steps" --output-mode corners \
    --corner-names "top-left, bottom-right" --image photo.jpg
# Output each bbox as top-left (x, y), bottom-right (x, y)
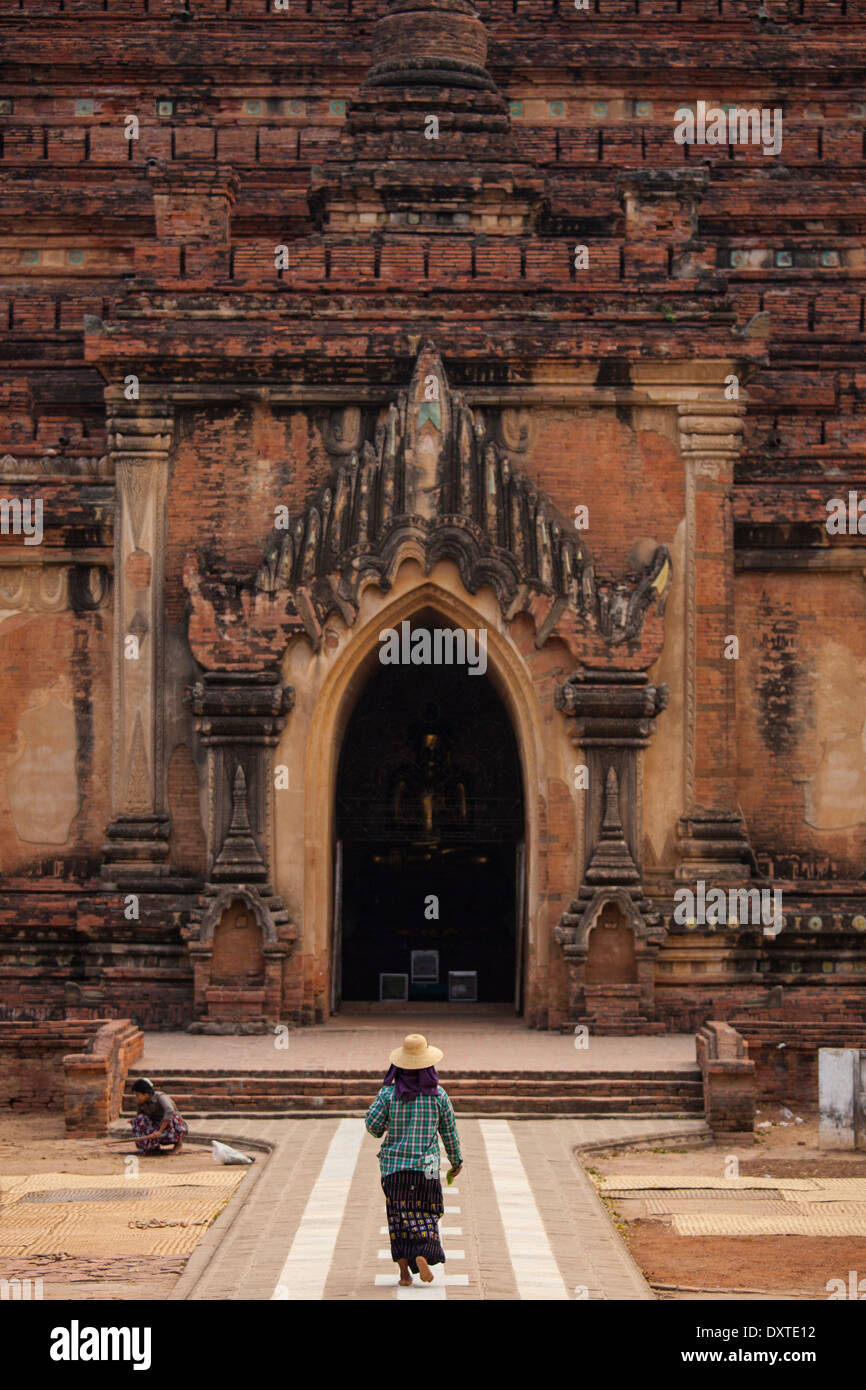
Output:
top-left (171, 1112), bottom-right (708, 1301)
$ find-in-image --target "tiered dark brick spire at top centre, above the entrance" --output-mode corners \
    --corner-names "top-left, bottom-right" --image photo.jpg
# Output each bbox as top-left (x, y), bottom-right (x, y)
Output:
top-left (309, 0), bottom-right (548, 236)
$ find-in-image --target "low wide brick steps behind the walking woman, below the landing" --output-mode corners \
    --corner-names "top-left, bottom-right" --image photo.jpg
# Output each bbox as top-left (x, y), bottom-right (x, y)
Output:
top-left (124, 1069), bottom-right (703, 1116)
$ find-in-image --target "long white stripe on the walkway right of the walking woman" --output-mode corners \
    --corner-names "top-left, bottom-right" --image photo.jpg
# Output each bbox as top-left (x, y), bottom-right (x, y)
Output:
top-left (478, 1120), bottom-right (569, 1300)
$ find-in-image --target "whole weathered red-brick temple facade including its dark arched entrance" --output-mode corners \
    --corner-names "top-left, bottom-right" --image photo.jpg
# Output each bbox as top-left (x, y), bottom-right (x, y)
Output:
top-left (0, 0), bottom-right (866, 1031)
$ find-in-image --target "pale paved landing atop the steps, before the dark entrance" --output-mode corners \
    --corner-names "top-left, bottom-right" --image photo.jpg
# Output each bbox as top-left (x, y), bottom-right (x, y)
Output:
top-left (139, 1012), bottom-right (696, 1086)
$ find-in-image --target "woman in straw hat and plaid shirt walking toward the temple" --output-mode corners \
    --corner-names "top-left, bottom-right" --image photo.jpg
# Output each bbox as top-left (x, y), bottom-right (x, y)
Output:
top-left (367, 1033), bottom-right (463, 1286)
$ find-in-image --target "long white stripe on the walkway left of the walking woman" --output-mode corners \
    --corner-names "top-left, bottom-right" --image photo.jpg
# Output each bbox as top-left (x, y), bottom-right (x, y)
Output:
top-left (271, 1119), bottom-right (364, 1298)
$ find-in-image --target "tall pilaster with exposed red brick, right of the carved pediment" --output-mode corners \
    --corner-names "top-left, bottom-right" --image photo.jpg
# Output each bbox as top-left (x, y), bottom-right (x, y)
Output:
top-left (677, 400), bottom-right (753, 883)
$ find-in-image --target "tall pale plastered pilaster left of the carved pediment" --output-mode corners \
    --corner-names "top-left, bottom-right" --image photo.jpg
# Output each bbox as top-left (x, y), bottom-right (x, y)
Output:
top-left (101, 386), bottom-right (174, 887)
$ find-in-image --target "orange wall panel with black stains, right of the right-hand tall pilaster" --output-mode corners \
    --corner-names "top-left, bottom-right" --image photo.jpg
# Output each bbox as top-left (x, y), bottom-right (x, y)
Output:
top-left (735, 572), bottom-right (866, 878)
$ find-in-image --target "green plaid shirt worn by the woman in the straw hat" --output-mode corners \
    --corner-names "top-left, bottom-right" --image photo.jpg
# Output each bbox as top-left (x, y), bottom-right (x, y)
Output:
top-left (367, 1086), bottom-right (463, 1177)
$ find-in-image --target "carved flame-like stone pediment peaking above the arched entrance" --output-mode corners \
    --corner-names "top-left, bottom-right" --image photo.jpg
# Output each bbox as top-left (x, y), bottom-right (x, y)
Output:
top-left (185, 343), bottom-right (671, 670)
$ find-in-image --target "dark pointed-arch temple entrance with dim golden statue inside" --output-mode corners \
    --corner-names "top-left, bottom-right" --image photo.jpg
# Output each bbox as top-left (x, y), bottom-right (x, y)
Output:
top-left (334, 620), bottom-right (524, 1009)
